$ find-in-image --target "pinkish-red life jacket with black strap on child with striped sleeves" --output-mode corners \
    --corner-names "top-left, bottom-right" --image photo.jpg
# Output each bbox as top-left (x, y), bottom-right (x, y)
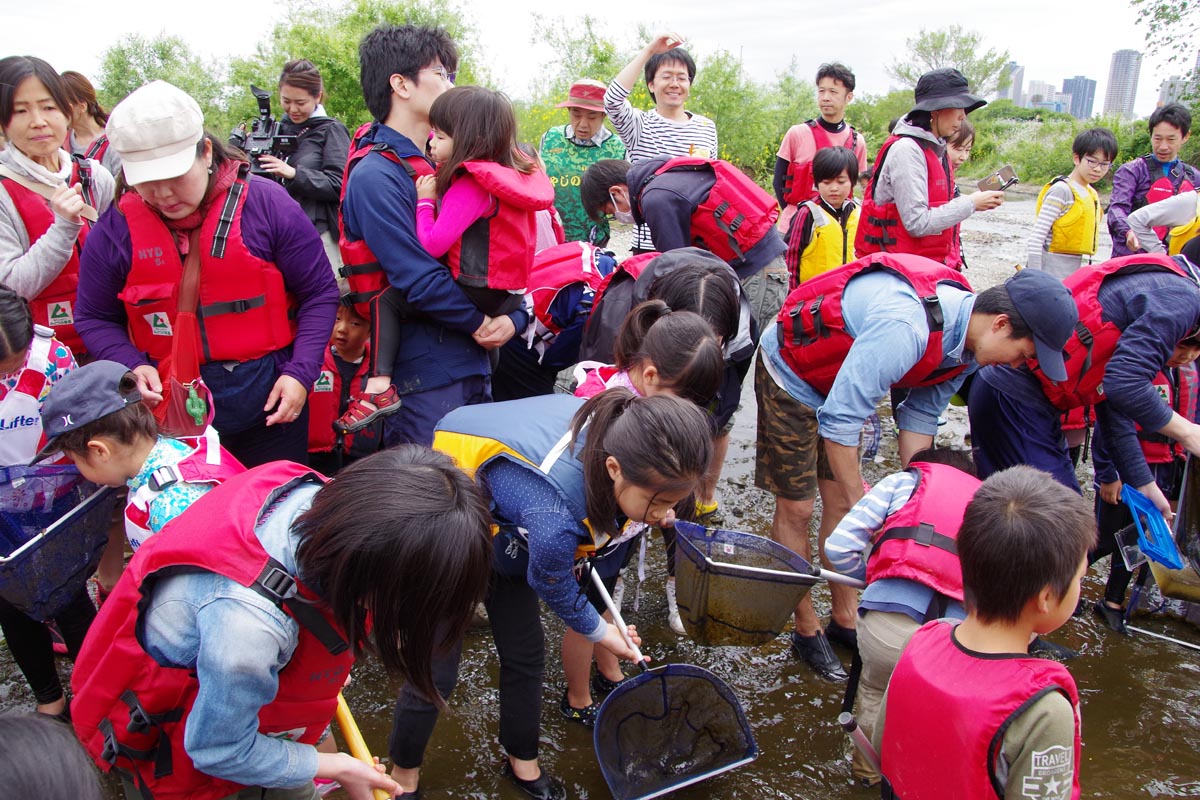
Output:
top-left (866, 462), bottom-right (980, 602)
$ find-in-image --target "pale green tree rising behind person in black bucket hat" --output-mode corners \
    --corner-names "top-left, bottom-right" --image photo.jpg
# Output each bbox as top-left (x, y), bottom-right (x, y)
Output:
top-left (887, 25), bottom-right (1009, 95)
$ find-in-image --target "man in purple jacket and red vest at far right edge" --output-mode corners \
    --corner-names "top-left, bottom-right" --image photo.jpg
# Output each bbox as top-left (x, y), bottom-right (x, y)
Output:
top-left (1108, 103), bottom-right (1200, 258)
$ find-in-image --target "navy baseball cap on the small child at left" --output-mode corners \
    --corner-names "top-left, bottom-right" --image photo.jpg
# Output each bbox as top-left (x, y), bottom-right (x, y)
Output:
top-left (32, 361), bottom-right (142, 464)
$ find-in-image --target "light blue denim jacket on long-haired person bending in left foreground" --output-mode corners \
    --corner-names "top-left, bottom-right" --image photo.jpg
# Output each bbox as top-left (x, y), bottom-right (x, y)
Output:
top-left (143, 485), bottom-right (318, 788)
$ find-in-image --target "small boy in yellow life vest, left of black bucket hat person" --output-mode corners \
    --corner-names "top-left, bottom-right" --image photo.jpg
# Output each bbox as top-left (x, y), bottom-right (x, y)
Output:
top-left (784, 148), bottom-right (858, 289)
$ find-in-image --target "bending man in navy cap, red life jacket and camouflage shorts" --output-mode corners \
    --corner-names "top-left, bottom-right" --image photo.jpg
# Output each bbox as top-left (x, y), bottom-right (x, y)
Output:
top-left (755, 262), bottom-right (1075, 681)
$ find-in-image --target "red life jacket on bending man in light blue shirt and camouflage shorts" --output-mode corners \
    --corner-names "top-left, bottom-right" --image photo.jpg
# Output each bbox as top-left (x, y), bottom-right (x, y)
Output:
top-left (778, 251), bottom-right (972, 395)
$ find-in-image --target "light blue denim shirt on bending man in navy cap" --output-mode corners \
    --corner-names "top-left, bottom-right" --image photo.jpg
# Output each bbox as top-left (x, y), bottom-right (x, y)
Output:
top-left (760, 267), bottom-right (976, 447)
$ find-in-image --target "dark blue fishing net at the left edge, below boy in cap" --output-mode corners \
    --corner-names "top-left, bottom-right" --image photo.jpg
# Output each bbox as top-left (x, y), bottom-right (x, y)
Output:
top-left (0, 467), bottom-right (115, 619)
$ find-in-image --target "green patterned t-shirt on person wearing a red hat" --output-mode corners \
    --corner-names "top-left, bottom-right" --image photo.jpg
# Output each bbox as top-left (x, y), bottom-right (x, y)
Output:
top-left (540, 125), bottom-right (625, 243)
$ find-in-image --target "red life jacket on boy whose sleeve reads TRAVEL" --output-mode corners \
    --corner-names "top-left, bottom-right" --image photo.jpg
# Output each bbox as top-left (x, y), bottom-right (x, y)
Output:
top-left (880, 621), bottom-right (1081, 800)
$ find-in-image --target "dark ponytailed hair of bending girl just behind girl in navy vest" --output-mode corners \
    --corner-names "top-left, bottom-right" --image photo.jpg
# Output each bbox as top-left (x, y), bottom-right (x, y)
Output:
top-left (613, 300), bottom-right (725, 407)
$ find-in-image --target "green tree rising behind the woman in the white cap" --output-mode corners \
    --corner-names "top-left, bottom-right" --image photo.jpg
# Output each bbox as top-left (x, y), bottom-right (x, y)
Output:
top-left (97, 34), bottom-right (228, 131)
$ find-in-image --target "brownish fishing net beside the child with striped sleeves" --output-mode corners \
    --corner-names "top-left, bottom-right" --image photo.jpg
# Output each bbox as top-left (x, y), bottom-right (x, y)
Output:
top-left (676, 522), bottom-right (817, 646)
